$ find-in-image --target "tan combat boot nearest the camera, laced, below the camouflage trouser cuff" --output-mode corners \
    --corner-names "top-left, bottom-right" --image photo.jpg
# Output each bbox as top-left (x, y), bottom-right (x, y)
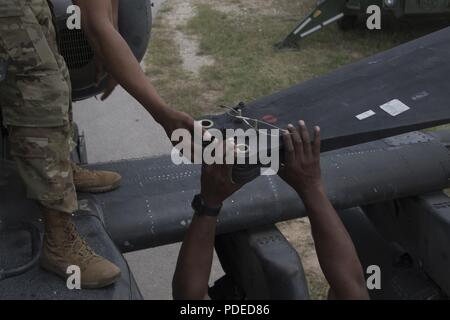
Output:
top-left (40, 209), bottom-right (120, 289)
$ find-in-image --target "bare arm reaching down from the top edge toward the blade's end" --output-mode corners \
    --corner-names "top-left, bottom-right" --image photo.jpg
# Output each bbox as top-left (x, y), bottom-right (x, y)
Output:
top-left (74, 0), bottom-right (193, 137)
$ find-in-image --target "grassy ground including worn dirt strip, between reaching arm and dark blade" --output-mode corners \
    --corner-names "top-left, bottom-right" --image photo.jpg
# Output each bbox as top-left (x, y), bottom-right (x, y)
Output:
top-left (147, 0), bottom-right (446, 116)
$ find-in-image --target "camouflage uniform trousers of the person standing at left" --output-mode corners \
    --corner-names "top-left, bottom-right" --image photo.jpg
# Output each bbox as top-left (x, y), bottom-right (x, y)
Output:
top-left (0, 0), bottom-right (77, 213)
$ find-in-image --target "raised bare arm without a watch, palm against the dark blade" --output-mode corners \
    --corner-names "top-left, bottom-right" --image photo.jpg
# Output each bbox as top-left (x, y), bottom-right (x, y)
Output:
top-left (281, 121), bottom-right (369, 299)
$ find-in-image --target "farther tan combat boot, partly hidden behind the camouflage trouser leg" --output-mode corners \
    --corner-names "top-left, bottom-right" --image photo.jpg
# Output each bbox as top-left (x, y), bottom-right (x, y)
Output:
top-left (72, 163), bottom-right (122, 193)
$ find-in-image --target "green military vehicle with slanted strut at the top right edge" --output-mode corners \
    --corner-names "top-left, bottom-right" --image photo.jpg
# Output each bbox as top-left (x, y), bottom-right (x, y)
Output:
top-left (278, 0), bottom-right (450, 48)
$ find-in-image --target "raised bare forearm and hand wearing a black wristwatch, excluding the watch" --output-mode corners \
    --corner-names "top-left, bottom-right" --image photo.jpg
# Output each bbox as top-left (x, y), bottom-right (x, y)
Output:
top-left (172, 141), bottom-right (242, 300)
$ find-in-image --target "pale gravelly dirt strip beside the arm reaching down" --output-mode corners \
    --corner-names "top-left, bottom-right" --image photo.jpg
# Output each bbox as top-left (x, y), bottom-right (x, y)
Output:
top-left (143, 0), bottom-right (218, 117)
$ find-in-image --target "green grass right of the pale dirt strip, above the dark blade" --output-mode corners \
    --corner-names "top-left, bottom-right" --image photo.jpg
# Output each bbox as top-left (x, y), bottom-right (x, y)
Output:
top-left (187, 0), bottom-right (446, 109)
